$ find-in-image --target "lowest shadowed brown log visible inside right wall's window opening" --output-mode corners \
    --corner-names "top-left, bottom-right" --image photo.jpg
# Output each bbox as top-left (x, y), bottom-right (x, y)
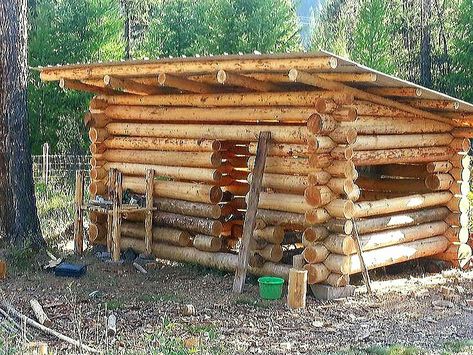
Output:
top-left (356, 177), bottom-right (429, 193)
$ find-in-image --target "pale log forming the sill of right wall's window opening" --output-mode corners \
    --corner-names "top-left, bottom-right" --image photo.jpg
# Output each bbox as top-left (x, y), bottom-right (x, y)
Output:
top-left (353, 192), bottom-right (452, 218)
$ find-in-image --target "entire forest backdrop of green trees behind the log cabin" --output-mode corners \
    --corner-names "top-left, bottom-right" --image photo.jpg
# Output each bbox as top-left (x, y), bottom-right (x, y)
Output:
top-left (28, 0), bottom-right (473, 154)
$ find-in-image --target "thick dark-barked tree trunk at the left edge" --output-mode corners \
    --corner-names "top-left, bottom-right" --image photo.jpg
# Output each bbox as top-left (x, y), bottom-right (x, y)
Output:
top-left (0, 0), bottom-right (45, 248)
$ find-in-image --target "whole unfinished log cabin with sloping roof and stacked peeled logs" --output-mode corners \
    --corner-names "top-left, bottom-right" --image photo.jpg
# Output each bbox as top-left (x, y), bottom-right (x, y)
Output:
top-left (40, 52), bottom-right (473, 291)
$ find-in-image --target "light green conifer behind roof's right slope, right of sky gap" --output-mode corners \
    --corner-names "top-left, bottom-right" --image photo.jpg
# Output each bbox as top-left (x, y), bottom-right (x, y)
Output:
top-left (351, 0), bottom-right (395, 73)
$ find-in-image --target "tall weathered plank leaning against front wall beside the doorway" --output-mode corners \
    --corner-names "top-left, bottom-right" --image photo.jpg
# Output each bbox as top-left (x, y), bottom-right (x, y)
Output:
top-left (233, 132), bottom-right (271, 293)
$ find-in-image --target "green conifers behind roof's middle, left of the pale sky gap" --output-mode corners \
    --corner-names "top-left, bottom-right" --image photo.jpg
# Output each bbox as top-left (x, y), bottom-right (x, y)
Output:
top-left (140, 0), bottom-right (300, 57)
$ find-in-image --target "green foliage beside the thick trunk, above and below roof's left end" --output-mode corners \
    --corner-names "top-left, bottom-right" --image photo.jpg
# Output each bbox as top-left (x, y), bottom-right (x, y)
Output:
top-left (28, 0), bottom-right (123, 154)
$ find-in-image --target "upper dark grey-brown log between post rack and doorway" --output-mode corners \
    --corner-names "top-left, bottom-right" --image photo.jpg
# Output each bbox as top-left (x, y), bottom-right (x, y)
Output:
top-left (154, 197), bottom-right (222, 219)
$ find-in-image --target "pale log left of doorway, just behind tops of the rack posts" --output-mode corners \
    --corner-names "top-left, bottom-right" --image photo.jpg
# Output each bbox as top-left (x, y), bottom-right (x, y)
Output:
top-left (90, 162), bottom-right (222, 183)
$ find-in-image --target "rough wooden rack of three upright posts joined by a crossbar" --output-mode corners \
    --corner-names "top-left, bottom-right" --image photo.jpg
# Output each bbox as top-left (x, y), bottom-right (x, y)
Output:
top-left (74, 169), bottom-right (156, 261)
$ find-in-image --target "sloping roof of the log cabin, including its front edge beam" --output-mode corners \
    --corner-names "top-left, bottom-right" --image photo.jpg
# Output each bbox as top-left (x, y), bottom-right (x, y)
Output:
top-left (38, 51), bottom-right (473, 123)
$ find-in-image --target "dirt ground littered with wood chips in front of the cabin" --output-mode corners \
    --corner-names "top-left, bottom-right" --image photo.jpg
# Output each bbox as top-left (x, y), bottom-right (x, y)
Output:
top-left (0, 252), bottom-right (473, 354)
